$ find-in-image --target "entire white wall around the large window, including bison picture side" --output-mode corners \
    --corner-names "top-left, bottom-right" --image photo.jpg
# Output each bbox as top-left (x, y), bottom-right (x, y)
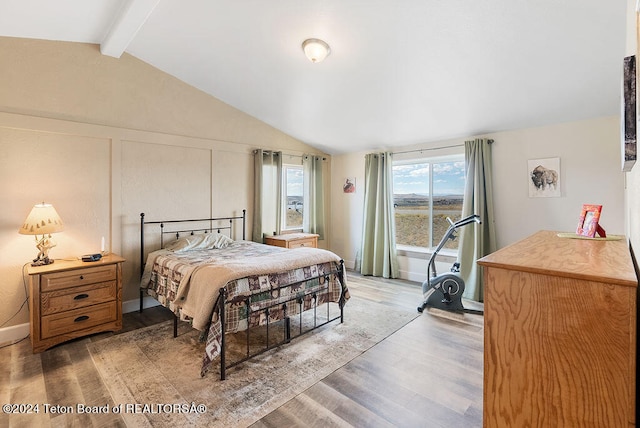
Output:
top-left (331, 117), bottom-right (625, 280)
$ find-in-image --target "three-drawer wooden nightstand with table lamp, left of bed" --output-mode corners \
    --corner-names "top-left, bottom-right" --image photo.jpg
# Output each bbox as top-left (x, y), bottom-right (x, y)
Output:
top-left (28, 255), bottom-right (124, 353)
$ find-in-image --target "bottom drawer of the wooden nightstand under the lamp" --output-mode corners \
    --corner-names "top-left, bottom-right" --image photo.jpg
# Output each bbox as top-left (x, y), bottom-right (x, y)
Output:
top-left (40, 301), bottom-right (118, 339)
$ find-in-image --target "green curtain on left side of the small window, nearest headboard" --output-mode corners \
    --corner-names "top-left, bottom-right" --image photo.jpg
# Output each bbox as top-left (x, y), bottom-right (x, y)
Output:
top-left (251, 149), bottom-right (282, 242)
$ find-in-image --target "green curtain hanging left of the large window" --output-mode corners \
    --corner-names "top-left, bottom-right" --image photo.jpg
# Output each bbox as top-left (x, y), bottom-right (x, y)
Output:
top-left (360, 153), bottom-right (399, 278)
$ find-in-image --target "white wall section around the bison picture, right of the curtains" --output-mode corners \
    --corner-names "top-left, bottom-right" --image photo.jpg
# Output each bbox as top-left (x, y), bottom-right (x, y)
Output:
top-left (492, 116), bottom-right (624, 247)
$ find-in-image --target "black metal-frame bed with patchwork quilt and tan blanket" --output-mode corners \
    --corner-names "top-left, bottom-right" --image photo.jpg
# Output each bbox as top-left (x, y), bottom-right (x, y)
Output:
top-left (140, 210), bottom-right (349, 380)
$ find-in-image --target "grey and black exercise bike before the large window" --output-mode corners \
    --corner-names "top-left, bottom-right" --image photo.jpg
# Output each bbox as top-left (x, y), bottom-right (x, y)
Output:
top-left (418, 214), bottom-right (484, 314)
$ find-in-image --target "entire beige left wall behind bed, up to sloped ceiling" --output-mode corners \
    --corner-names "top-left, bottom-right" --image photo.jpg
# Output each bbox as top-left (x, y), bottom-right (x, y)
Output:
top-left (0, 37), bottom-right (330, 343)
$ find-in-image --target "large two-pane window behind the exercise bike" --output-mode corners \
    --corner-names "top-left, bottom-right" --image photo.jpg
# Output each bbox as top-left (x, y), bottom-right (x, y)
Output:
top-left (393, 155), bottom-right (465, 249)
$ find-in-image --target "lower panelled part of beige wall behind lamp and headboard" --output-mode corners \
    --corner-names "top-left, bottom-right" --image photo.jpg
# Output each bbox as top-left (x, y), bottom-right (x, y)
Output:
top-left (0, 117), bottom-right (260, 334)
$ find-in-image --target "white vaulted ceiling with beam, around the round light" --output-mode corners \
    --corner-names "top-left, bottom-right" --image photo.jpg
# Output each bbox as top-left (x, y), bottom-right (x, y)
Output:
top-left (0, 0), bottom-right (627, 154)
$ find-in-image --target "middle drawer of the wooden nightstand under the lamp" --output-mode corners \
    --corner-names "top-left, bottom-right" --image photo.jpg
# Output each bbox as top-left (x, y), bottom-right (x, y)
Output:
top-left (40, 281), bottom-right (116, 315)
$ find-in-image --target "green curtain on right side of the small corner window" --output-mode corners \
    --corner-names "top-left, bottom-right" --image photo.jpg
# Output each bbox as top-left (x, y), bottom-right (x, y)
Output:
top-left (302, 155), bottom-right (324, 239)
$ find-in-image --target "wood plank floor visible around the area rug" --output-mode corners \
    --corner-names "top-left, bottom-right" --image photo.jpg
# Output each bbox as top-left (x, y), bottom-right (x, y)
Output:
top-left (0, 273), bottom-right (483, 428)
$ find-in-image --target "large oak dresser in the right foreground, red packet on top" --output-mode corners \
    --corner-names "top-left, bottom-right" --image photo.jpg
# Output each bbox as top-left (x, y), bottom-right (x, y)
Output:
top-left (478, 231), bottom-right (638, 427)
